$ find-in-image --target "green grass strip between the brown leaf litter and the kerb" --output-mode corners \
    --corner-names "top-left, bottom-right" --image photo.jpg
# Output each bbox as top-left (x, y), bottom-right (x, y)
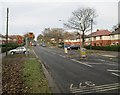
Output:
top-left (23, 58), bottom-right (51, 93)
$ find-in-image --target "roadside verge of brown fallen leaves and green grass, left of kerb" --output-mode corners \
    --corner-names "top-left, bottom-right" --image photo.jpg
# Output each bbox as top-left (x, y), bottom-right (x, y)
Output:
top-left (2, 46), bottom-right (51, 95)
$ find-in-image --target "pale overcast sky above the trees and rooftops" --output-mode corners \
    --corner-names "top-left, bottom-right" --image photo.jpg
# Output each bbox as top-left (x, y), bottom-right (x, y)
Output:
top-left (0, 0), bottom-right (119, 40)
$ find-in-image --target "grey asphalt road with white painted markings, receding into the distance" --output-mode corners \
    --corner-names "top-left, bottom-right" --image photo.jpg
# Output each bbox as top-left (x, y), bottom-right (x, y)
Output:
top-left (34, 46), bottom-right (120, 93)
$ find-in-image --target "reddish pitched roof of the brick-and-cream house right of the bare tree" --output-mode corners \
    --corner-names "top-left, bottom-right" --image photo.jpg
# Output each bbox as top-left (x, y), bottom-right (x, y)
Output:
top-left (88, 30), bottom-right (112, 37)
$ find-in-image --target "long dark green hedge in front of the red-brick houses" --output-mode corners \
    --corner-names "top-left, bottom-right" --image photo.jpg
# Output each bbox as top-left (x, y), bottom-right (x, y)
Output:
top-left (85, 45), bottom-right (120, 52)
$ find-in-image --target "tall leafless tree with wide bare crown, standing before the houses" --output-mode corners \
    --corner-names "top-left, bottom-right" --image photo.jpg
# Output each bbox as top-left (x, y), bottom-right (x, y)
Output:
top-left (64, 8), bottom-right (97, 47)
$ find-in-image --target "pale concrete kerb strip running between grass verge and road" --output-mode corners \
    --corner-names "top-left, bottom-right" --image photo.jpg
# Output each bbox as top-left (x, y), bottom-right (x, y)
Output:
top-left (32, 49), bottom-right (60, 93)
